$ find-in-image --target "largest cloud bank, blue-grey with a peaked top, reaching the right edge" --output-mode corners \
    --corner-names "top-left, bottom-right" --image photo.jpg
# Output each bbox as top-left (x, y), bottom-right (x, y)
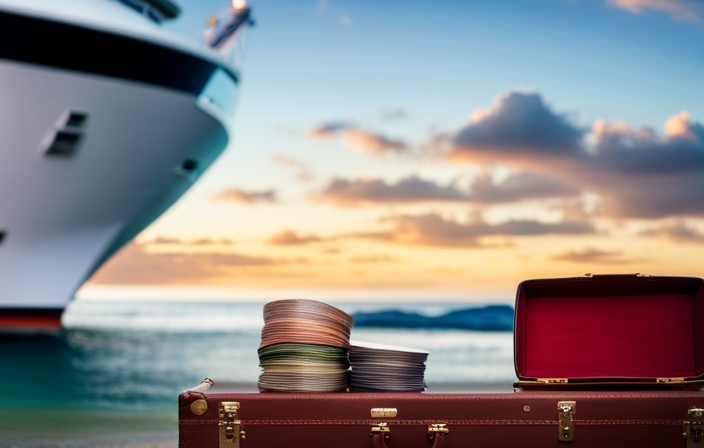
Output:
top-left (446, 92), bottom-right (704, 219)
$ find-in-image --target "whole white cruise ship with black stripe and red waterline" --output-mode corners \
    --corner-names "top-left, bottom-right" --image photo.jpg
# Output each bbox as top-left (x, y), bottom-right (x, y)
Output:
top-left (0, 0), bottom-right (252, 331)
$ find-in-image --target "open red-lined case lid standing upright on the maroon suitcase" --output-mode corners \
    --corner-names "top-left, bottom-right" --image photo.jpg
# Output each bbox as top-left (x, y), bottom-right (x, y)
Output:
top-left (514, 274), bottom-right (704, 385)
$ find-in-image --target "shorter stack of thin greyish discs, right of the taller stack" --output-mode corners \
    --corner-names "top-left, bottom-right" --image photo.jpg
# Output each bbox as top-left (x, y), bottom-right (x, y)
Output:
top-left (350, 341), bottom-right (430, 392)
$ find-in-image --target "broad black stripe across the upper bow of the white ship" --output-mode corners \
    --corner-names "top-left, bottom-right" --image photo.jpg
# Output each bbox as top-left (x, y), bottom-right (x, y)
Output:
top-left (0, 12), bottom-right (237, 95)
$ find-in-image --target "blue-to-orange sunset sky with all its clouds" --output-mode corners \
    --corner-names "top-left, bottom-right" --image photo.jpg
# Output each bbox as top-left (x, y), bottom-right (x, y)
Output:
top-left (87, 0), bottom-right (704, 301)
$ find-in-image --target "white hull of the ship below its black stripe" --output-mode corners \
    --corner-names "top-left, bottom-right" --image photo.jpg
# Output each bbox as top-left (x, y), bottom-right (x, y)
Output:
top-left (0, 0), bottom-right (235, 327)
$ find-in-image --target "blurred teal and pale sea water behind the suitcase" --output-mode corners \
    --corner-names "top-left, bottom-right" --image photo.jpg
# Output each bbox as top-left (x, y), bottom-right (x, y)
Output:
top-left (0, 300), bottom-right (515, 448)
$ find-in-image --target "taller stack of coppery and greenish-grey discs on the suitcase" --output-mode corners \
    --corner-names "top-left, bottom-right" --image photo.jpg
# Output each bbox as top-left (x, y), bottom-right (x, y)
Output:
top-left (258, 299), bottom-right (352, 392)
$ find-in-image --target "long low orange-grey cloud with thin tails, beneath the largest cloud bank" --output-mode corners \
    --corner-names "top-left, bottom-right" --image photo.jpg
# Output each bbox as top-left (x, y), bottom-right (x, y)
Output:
top-left (347, 213), bottom-right (594, 248)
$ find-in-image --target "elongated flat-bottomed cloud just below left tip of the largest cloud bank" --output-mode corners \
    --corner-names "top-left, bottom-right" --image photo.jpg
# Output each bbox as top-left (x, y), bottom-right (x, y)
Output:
top-left (317, 175), bottom-right (468, 205)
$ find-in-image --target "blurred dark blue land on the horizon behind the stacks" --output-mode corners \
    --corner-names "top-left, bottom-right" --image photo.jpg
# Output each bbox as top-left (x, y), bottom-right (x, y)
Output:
top-left (352, 305), bottom-right (513, 331)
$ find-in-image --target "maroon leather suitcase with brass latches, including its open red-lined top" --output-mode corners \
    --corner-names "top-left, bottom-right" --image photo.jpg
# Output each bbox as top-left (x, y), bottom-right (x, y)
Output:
top-left (179, 275), bottom-right (704, 448)
